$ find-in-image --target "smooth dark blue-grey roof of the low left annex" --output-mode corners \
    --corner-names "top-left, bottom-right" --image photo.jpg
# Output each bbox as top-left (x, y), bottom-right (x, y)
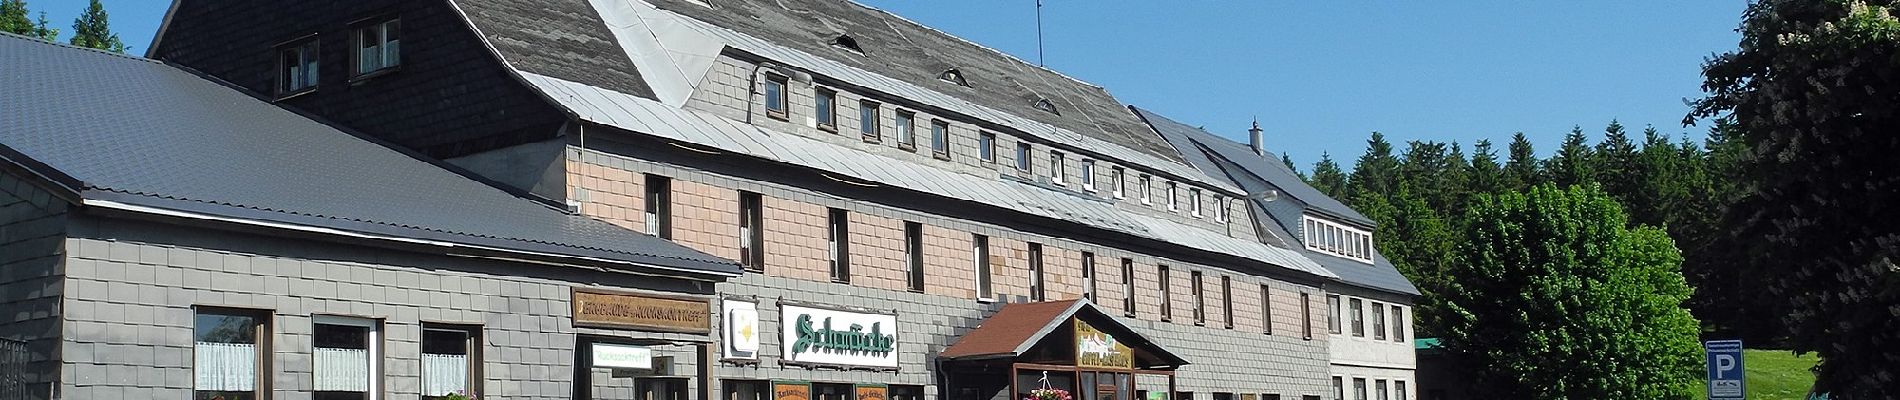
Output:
top-left (0, 34), bottom-right (739, 275)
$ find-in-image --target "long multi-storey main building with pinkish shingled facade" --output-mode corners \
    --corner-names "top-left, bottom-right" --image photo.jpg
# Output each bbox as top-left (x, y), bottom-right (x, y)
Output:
top-left (148, 0), bottom-right (1368, 400)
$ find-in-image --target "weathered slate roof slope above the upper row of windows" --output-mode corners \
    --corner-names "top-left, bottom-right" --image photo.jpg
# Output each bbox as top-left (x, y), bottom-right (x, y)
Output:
top-left (638, 0), bottom-right (1178, 161)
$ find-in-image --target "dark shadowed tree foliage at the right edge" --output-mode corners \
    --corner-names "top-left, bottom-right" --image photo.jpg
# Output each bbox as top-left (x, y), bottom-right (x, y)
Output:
top-left (1685, 0), bottom-right (1900, 394)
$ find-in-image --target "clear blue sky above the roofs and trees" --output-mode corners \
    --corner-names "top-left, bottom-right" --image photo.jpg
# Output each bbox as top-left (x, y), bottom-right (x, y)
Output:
top-left (29, 0), bottom-right (1746, 169)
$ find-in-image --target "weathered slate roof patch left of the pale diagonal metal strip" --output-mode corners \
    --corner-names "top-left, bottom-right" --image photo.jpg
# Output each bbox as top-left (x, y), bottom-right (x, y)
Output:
top-left (450, 0), bottom-right (654, 99)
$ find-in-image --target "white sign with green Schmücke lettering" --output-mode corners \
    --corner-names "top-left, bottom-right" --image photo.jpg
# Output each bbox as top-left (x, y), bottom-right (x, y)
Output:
top-left (779, 303), bottom-right (897, 368)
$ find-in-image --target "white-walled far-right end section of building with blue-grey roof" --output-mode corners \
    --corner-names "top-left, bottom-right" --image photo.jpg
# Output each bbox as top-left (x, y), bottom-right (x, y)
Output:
top-left (1129, 106), bottom-right (1419, 400)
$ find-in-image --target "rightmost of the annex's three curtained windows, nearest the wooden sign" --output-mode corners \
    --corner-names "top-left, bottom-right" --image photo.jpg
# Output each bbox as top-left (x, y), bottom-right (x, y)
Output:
top-left (422, 324), bottom-right (486, 398)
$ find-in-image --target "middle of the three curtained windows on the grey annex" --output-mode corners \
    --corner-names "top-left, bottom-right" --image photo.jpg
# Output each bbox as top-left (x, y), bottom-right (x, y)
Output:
top-left (310, 315), bottom-right (382, 400)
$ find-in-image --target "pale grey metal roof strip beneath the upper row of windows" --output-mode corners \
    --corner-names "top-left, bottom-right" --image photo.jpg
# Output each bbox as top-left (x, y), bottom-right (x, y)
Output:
top-left (523, 72), bottom-right (1334, 279)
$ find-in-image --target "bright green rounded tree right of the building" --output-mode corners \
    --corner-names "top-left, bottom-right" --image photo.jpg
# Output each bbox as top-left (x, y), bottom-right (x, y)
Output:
top-left (1427, 184), bottom-right (1701, 400)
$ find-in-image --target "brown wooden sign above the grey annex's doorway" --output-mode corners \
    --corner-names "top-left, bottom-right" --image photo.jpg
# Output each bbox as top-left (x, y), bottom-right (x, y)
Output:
top-left (570, 288), bottom-right (713, 334)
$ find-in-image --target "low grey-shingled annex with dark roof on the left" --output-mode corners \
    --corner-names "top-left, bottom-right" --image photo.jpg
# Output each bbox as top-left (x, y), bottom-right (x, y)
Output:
top-left (0, 34), bottom-right (741, 400)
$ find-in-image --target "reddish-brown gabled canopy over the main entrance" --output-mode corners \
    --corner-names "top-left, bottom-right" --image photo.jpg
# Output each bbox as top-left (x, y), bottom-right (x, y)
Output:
top-left (939, 300), bottom-right (1188, 370)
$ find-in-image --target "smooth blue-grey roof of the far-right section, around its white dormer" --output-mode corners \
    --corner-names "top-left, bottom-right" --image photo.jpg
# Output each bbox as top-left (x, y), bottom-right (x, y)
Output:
top-left (1131, 106), bottom-right (1419, 296)
